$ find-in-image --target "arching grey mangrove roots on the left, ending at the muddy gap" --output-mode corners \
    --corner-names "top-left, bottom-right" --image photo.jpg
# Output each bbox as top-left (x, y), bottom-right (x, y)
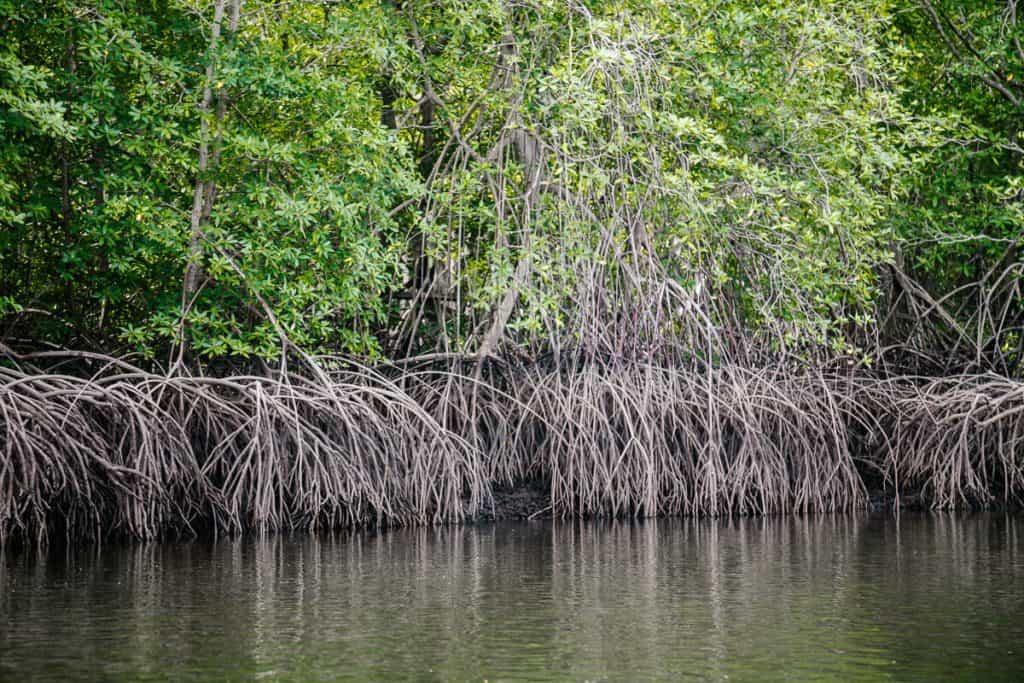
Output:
top-left (0, 360), bottom-right (488, 539)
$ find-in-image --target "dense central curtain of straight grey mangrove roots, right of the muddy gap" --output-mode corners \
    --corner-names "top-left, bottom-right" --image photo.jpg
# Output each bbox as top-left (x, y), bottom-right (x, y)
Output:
top-left (411, 364), bottom-right (866, 516)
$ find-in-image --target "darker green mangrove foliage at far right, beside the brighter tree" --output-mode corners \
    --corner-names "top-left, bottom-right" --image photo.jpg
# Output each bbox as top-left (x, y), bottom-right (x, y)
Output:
top-left (885, 0), bottom-right (1024, 374)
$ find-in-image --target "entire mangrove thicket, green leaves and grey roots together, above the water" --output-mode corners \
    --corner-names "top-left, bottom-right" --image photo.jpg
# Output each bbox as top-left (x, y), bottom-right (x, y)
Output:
top-left (0, 0), bottom-right (1024, 538)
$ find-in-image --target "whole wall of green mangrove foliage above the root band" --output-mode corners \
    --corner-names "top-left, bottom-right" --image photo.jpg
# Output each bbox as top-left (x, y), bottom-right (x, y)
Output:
top-left (0, 0), bottom-right (1024, 374)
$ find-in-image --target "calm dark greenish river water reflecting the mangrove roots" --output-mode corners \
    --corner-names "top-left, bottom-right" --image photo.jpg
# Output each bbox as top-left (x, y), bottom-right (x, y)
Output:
top-left (0, 515), bottom-right (1024, 682)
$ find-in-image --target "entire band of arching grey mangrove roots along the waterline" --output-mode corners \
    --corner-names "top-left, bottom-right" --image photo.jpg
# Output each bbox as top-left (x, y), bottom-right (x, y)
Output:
top-left (0, 360), bottom-right (1024, 538)
